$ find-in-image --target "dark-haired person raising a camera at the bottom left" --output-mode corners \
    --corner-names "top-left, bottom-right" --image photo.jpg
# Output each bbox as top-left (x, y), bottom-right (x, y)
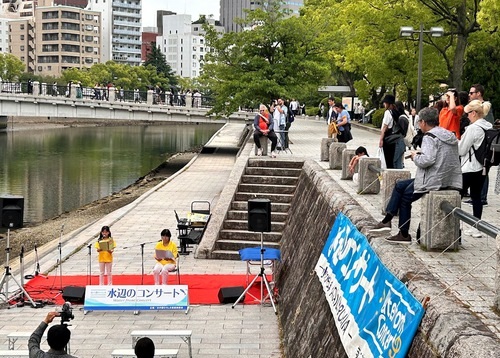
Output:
top-left (28, 312), bottom-right (76, 358)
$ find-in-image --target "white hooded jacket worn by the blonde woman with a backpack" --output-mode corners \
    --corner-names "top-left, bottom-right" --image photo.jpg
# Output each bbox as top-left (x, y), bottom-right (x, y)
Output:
top-left (458, 118), bottom-right (493, 173)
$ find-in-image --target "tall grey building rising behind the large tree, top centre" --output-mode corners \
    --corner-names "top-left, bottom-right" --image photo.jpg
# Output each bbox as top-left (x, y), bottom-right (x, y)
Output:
top-left (220, 0), bottom-right (304, 32)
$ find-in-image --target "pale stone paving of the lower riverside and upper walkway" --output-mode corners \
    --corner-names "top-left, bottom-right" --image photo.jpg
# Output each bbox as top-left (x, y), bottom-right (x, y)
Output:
top-left (0, 117), bottom-right (500, 358)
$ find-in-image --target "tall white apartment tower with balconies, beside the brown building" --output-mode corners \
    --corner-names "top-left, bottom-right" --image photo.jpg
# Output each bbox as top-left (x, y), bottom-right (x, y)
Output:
top-left (87, 0), bottom-right (142, 66)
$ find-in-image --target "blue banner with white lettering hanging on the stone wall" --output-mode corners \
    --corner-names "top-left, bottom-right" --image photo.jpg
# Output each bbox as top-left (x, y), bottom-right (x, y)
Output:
top-left (315, 213), bottom-right (424, 358)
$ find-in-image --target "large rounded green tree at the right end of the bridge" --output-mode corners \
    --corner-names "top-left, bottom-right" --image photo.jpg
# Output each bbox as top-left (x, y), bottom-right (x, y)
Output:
top-left (200, 1), bottom-right (329, 114)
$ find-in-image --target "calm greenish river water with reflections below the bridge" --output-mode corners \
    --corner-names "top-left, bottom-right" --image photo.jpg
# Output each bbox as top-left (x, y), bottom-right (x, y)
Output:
top-left (0, 124), bottom-right (221, 223)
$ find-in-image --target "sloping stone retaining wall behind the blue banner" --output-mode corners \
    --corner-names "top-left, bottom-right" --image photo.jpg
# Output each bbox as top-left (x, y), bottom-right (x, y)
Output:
top-left (276, 161), bottom-right (500, 358)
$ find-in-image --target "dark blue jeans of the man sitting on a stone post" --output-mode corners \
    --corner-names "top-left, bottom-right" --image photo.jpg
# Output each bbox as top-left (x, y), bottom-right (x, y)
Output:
top-left (385, 179), bottom-right (425, 234)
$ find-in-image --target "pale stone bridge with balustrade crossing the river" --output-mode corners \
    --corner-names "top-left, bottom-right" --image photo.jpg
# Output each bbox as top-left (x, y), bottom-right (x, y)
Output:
top-left (0, 82), bottom-right (254, 129)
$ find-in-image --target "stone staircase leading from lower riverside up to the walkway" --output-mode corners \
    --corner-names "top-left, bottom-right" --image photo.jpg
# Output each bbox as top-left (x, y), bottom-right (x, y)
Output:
top-left (212, 158), bottom-right (304, 260)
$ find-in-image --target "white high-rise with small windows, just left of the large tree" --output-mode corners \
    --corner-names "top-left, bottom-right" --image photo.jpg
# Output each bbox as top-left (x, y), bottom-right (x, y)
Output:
top-left (156, 14), bottom-right (224, 78)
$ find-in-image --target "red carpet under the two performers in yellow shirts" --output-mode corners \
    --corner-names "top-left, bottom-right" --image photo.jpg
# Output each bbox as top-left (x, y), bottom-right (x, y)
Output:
top-left (24, 274), bottom-right (270, 305)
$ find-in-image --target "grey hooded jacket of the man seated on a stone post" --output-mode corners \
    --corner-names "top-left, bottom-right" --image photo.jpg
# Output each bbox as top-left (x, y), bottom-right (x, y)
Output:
top-left (413, 127), bottom-right (462, 193)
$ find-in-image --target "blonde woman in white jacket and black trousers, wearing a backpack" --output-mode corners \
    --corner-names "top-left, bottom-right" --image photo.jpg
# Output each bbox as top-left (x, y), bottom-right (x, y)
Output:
top-left (458, 100), bottom-right (493, 219)
